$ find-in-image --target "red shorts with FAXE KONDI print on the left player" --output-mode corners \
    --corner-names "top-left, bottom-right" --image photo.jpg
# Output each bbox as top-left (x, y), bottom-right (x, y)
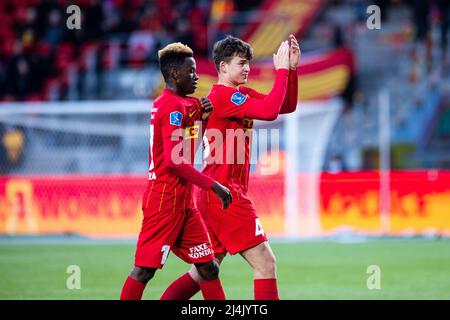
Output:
top-left (134, 208), bottom-right (214, 269)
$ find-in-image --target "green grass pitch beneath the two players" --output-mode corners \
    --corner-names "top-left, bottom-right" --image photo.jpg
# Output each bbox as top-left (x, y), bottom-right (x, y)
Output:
top-left (0, 240), bottom-right (450, 300)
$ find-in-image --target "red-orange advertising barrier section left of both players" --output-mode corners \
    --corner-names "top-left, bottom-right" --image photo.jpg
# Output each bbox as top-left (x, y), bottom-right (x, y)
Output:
top-left (0, 176), bottom-right (146, 236)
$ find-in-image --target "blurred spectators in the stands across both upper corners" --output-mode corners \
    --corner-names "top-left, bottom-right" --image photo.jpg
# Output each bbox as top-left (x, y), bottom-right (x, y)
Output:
top-left (0, 0), bottom-right (450, 101)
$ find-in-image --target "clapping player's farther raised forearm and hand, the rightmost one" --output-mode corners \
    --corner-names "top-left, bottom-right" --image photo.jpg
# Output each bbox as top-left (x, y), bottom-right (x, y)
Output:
top-left (280, 34), bottom-right (301, 114)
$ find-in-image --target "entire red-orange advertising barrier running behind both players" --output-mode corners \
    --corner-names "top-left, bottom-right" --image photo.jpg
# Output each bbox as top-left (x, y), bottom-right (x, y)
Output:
top-left (0, 171), bottom-right (450, 237)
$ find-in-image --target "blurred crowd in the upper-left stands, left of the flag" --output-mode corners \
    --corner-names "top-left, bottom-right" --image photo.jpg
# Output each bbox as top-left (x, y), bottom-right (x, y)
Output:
top-left (0, 0), bottom-right (221, 101)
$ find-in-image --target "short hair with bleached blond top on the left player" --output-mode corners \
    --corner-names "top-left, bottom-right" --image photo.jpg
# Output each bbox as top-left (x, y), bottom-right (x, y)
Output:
top-left (158, 42), bottom-right (194, 82)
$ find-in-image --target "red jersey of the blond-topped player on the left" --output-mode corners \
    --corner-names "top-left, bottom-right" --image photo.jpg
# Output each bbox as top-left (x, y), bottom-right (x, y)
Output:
top-left (142, 89), bottom-right (214, 212)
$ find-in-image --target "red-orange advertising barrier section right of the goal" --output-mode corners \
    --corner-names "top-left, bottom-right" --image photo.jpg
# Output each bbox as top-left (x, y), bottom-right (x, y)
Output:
top-left (320, 170), bottom-right (450, 234)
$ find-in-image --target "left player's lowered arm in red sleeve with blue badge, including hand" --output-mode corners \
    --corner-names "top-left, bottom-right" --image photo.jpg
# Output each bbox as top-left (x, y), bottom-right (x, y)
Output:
top-left (160, 106), bottom-right (232, 209)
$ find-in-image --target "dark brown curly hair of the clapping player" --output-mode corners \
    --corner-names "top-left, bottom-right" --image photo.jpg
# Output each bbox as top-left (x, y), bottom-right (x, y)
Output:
top-left (213, 36), bottom-right (253, 71)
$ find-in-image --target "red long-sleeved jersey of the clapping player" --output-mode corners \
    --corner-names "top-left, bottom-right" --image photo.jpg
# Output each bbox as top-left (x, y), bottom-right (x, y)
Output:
top-left (198, 69), bottom-right (297, 202)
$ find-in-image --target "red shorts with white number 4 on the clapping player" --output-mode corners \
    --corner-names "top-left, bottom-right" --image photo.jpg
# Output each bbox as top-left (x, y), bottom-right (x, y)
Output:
top-left (197, 199), bottom-right (267, 254)
